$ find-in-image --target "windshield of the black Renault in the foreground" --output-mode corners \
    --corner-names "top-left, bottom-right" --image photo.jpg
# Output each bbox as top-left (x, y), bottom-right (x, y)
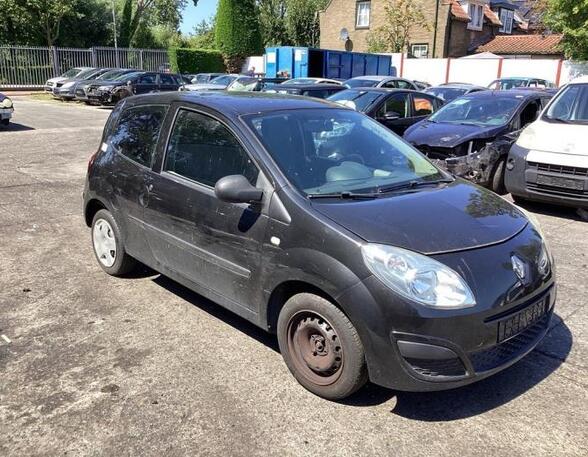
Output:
top-left (245, 109), bottom-right (440, 196)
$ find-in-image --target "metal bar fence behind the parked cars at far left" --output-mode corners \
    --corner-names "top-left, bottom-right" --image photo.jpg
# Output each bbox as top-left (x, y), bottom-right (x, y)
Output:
top-left (0, 46), bottom-right (169, 89)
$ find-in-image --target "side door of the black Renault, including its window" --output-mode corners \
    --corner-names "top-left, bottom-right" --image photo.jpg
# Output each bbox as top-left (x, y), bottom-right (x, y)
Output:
top-left (145, 107), bottom-right (267, 312)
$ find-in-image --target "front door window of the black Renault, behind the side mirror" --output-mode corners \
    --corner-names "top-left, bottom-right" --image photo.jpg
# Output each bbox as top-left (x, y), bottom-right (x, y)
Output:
top-left (164, 110), bottom-right (259, 187)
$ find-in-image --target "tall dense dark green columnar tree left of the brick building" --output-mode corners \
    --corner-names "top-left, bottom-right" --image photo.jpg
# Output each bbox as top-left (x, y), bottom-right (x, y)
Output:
top-left (215, 0), bottom-right (263, 72)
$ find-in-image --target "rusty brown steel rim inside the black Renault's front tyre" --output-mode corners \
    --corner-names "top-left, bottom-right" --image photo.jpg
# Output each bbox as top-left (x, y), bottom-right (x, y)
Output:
top-left (288, 311), bottom-right (345, 386)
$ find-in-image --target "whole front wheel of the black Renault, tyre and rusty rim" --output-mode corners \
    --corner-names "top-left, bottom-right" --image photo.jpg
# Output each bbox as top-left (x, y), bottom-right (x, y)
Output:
top-left (277, 293), bottom-right (368, 400)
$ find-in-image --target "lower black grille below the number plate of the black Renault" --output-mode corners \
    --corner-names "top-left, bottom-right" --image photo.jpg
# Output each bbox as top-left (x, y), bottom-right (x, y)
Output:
top-left (469, 313), bottom-right (551, 372)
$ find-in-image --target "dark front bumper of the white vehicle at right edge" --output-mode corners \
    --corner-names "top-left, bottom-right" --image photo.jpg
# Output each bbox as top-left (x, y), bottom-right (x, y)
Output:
top-left (504, 143), bottom-right (588, 209)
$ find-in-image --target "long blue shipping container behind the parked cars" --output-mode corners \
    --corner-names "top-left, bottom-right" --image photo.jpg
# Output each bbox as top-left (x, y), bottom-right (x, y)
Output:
top-left (265, 46), bottom-right (396, 79)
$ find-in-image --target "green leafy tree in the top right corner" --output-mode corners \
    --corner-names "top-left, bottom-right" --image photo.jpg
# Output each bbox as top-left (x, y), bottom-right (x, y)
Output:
top-left (543, 0), bottom-right (588, 60)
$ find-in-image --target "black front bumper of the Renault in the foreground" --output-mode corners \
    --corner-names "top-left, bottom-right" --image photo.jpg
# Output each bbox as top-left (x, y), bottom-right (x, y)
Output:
top-left (336, 226), bottom-right (556, 391)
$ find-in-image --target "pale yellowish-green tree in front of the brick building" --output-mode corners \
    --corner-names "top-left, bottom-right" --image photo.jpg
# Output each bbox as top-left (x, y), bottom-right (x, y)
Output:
top-left (367, 0), bottom-right (431, 52)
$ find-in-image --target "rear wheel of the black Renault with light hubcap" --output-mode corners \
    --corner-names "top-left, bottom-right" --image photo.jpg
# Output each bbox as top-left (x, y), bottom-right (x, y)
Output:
top-left (92, 209), bottom-right (137, 276)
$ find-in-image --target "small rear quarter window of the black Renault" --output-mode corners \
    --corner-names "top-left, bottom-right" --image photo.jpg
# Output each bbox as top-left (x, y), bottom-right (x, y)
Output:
top-left (110, 106), bottom-right (167, 167)
